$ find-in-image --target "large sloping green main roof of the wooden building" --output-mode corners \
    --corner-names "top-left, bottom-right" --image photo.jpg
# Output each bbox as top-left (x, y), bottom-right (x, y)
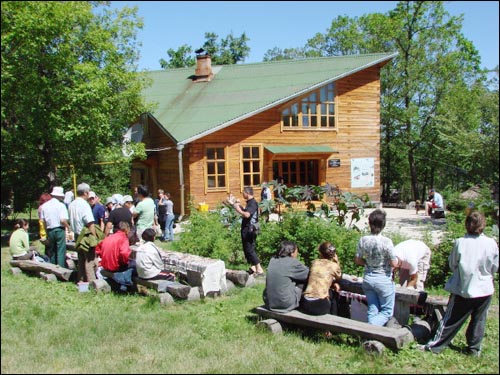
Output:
top-left (144, 53), bottom-right (397, 144)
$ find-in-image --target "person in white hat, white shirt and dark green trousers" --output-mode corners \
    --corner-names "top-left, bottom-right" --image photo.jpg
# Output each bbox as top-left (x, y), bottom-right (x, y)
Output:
top-left (40, 186), bottom-right (71, 268)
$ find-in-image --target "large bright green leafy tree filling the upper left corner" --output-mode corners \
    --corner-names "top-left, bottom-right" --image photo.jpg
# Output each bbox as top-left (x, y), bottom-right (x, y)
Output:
top-left (1, 1), bottom-right (147, 209)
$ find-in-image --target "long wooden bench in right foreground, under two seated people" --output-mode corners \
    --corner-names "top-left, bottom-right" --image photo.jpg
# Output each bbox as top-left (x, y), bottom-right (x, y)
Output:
top-left (254, 306), bottom-right (413, 350)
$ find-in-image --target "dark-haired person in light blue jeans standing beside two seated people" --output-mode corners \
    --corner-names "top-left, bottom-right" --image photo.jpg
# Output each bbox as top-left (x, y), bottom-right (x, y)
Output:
top-left (354, 209), bottom-right (398, 326)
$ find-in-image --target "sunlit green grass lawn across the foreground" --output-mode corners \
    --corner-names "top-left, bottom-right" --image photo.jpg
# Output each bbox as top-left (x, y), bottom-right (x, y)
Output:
top-left (1, 247), bottom-right (499, 374)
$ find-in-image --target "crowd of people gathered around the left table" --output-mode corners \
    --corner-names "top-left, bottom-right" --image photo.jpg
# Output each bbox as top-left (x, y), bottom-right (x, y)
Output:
top-left (9, 183), bottom-right (175, 290)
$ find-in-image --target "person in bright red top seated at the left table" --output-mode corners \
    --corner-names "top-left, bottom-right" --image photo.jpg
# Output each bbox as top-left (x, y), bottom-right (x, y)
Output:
top-left (95, 221), bottom-right (131, 272)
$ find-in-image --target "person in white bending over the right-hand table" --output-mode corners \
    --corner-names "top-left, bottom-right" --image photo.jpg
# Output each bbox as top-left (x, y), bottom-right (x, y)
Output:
top-left (394, 240), bottom-right (431, 290)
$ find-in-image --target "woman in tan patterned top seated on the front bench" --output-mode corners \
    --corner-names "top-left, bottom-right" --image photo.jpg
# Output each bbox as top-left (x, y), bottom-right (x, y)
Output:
top-left (301, 242), bottom-right (342, 315)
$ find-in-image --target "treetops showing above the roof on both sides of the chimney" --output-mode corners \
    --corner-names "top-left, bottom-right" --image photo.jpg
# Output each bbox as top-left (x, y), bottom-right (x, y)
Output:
top-left (160, 32), bottom-right (250, 69)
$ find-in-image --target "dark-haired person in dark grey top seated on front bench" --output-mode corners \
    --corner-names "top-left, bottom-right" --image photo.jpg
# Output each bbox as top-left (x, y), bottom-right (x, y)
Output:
top-left (263, 241), bottom-right (309, 312)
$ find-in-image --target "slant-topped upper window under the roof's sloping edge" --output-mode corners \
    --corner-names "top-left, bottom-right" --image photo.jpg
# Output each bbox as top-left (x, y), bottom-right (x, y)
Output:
top-left (281, 82), bottom-right (337, 130)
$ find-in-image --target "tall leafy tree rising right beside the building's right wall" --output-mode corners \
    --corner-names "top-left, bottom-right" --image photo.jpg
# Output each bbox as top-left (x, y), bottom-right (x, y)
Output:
top-left (284, 1), bottom-right (482, 203)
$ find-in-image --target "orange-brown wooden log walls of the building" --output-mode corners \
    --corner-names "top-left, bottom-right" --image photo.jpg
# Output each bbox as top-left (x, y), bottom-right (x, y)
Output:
top-left (132, 67), bottom-right (381, 213)
